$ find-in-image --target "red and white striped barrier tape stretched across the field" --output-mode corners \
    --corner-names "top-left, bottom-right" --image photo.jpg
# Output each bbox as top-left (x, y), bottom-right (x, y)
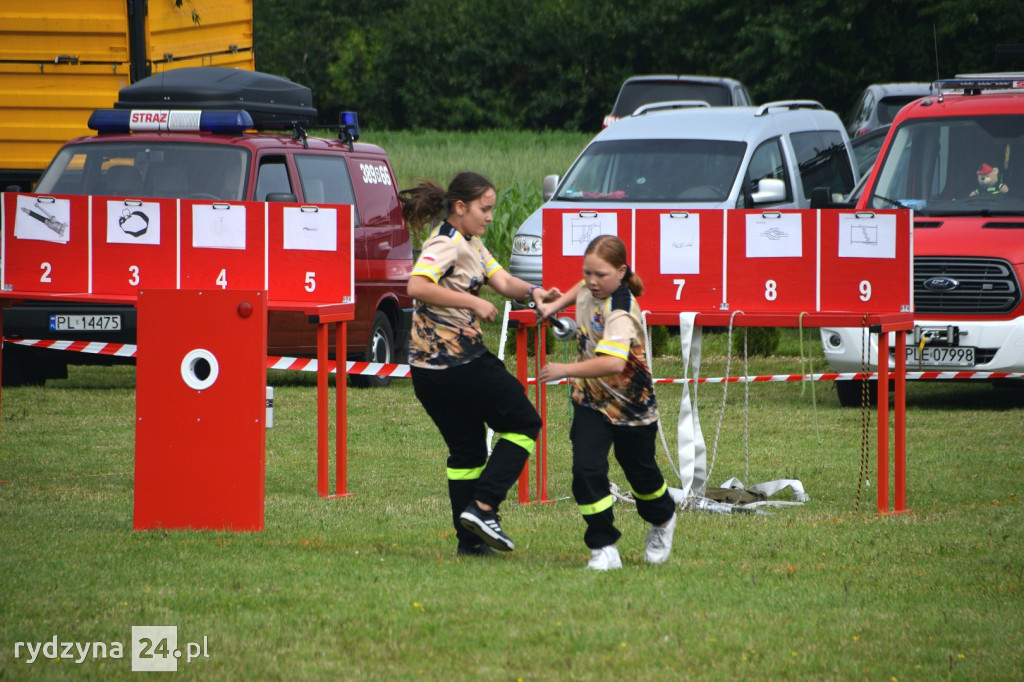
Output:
top-left (4, 339), bottom-right (1024, 386)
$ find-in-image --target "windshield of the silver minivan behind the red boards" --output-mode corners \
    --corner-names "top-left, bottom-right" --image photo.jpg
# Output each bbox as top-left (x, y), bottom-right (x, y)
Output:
top-left (555, 139), bottom-right (746, 203)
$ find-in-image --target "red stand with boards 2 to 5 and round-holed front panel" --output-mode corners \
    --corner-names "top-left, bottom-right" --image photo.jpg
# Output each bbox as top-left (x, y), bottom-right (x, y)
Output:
top-left (0, 194), bottom-right (355, 530)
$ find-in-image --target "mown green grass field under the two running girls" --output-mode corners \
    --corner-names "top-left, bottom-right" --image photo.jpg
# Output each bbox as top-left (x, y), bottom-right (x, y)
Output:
top-left (0, 324), bottom-right (1024, 680)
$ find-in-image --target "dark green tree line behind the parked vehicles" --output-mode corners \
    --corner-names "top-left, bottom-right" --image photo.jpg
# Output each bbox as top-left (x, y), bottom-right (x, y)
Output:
top-left (254, 0), bottom-right (1024, 131)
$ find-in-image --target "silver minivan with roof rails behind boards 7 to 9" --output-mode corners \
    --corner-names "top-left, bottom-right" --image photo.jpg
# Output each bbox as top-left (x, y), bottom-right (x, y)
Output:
top-left (509, 99), bottom-right (859, 285)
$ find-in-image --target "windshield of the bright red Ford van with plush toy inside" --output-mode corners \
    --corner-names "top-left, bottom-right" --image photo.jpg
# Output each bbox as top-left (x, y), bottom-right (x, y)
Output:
top-left (867, 116), bottom-right (1024, 215)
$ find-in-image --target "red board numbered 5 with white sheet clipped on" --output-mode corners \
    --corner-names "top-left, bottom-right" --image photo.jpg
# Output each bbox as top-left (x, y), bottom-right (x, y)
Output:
top-left (267, 203), bottom-right (355, 303)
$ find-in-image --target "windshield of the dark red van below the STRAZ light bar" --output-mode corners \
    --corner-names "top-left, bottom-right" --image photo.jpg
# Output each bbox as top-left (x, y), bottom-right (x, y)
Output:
top-left (35, 141), bottom-right (249, 201)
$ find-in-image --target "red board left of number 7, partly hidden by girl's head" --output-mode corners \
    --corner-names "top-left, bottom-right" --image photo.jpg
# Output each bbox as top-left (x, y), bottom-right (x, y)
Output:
top-left (543, 208), bottom-right (633, 291)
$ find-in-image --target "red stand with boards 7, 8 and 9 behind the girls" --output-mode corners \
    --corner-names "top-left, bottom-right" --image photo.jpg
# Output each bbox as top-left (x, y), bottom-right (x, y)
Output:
top-left (520, 206), bottom-right (913, 513)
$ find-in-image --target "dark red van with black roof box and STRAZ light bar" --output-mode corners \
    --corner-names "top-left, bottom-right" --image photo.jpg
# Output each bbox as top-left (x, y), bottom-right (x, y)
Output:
top-left (3, 67), bottom-right (413, 385)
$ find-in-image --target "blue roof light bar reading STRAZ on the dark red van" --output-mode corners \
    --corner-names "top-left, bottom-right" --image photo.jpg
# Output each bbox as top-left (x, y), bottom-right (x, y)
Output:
top-left (89, 109), bottom-right (255, 134)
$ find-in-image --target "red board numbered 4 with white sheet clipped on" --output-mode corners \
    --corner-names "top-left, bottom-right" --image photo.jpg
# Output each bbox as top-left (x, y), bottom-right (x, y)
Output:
top-left (179, 201), bottom-right (267, 291)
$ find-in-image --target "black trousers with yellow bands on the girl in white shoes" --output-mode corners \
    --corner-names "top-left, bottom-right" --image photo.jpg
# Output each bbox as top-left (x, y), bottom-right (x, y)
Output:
top-left (569, 403), bottom-right (676, 549)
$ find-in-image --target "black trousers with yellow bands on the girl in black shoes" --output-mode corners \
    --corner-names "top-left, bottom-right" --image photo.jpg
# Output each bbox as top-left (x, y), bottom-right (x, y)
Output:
top-left (412, 351), bottom-right (541, 543)
